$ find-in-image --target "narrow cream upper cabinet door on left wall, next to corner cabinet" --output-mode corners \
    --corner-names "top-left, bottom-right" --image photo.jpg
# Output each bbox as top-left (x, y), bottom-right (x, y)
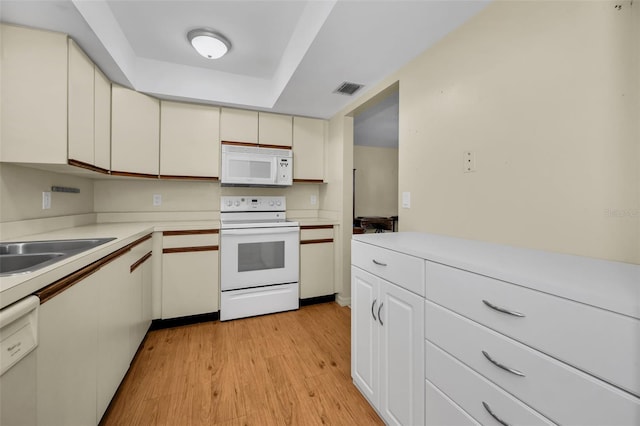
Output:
top-left (93, 67), bottom-right (111, 170)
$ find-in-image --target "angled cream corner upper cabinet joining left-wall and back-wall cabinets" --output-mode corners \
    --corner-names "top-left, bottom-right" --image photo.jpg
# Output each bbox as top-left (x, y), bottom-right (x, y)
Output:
top-left (111, 85), bottom-right (160, 175)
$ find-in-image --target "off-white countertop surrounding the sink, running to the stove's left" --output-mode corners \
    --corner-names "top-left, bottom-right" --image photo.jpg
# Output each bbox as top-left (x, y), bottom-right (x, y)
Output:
top-left (0, 220), bottom-right (220, 309)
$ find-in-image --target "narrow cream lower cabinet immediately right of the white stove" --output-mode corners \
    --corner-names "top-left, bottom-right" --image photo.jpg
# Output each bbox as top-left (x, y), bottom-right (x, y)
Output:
top-left (300, 225), bottom-right (335, 299)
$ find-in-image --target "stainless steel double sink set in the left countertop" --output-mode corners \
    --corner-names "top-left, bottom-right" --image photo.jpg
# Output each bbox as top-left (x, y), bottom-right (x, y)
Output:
top-left (0, 238), bottom-right (115, 276)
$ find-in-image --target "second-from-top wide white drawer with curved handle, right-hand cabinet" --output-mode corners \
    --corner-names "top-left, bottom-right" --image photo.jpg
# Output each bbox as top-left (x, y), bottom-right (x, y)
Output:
top-left (425, 301), bottom-right (640, 426)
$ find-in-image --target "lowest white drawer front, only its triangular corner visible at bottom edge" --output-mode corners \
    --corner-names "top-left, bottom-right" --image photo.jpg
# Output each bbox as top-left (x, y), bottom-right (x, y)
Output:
top-left (424, 380), bottom-right (480, 426)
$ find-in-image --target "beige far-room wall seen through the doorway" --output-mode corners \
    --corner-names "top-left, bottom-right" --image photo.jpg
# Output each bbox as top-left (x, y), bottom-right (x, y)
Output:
top-left (353, 145), bottom-right (398, 217)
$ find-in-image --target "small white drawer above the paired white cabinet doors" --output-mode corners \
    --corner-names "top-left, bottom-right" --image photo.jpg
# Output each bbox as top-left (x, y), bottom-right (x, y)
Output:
top-left (351, 241), bottom-right (425, 296)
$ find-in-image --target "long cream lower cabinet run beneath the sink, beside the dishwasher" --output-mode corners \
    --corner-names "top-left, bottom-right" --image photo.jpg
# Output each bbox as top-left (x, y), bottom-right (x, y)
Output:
top-left (37, 235), bottom-right (151, 426)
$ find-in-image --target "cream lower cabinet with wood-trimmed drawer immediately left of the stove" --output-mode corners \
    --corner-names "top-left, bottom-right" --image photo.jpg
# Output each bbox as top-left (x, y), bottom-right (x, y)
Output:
top-left (162, 229), bottom-right (220, 319)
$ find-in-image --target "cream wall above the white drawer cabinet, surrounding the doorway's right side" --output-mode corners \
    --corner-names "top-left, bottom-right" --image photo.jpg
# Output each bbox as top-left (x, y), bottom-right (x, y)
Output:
top-left (331, 1), bottom-right (640, 263)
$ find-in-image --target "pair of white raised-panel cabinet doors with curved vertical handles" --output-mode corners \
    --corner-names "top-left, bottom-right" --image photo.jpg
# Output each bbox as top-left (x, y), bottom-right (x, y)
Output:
top-left (351, 266), bottom-right (424, 425)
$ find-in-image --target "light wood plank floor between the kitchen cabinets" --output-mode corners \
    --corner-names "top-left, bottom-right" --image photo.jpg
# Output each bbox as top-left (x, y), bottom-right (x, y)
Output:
top-left (101, 303), bottom-right (384, 426)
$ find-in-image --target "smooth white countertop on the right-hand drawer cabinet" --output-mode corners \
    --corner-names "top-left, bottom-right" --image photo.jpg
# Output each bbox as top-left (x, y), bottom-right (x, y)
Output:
top-left (353, 232), bottom-right (640, 318)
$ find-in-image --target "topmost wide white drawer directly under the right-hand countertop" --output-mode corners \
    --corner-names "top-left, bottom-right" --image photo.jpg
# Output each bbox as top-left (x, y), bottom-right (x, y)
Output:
top-left (426, 262), bottom-right (640, 395)
